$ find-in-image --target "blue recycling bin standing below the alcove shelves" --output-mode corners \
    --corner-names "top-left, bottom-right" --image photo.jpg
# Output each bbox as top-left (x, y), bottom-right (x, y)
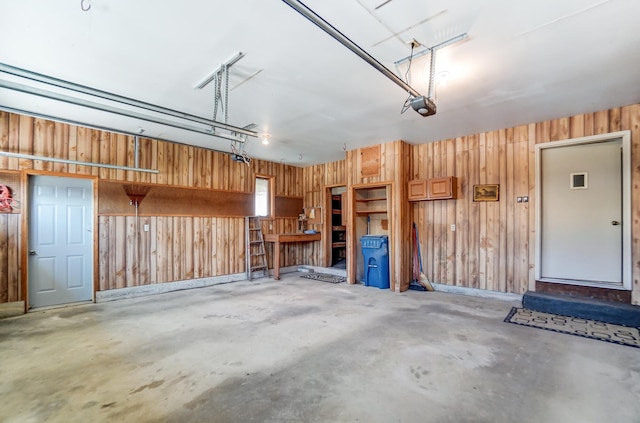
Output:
top-left (360, 235), bottom-right (389, 289)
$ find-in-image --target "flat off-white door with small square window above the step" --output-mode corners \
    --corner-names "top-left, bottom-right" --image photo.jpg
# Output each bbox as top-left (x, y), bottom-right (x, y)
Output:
top-left (540, 139), bottom-right (626, 287)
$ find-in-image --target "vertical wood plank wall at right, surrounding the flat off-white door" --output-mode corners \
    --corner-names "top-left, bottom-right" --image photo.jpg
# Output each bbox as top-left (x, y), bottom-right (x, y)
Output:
top-left (412, 105), bottom-right (640, 304)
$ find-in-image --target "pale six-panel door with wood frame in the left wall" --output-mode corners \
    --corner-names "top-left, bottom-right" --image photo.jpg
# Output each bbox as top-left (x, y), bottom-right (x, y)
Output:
top-left (29, 176), bottom-right (93, 307)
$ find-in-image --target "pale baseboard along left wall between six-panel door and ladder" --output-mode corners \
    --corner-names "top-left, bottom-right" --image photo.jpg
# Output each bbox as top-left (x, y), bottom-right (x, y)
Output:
top-left (96, 273), bottom-right (247, 303)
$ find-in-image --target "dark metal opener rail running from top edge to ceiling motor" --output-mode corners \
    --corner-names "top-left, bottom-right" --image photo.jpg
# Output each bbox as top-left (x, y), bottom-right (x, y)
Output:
top-left (282, 0), bottom-right (422, 97)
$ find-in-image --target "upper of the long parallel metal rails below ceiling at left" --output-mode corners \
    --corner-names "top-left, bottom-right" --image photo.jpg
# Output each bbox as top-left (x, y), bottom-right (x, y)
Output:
top-left (0, 63), bottom-right (258, 138)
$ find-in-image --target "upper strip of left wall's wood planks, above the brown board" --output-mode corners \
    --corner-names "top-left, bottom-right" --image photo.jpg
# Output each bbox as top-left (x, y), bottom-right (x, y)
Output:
top-left (0, 112), bottom-right (304, 193)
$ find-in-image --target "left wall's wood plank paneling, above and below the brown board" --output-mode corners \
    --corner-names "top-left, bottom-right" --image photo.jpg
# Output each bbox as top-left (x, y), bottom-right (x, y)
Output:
top-left (0, 112), bottom-right (305, 302)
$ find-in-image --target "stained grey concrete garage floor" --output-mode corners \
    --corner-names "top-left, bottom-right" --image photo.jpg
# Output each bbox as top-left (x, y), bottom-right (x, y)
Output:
top-left (0, 274), bottom-right (640, 423)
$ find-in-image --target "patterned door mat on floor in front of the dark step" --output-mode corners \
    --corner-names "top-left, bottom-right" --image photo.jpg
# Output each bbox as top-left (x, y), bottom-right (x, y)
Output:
top-left (504, 307), bottom-right (640, 348)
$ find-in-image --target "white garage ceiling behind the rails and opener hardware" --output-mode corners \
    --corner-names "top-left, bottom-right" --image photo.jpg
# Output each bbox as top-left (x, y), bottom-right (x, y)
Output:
top-left (0, 0), bottom-right (640, 166)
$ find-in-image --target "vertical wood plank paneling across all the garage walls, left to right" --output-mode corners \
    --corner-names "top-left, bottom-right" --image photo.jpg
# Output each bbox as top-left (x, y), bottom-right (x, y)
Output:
top-left (0, 105), bottom-right (640, 304)
